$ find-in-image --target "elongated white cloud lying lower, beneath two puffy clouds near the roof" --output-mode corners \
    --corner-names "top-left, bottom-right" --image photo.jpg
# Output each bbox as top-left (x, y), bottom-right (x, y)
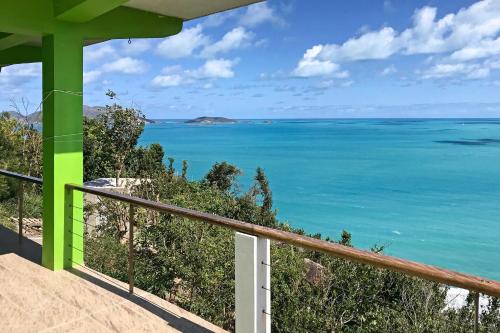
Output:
top-left (151, 59), bottom-right (238, 89)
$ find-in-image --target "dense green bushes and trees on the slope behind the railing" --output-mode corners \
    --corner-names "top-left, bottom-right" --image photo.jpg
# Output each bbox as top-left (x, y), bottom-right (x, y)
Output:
top-left (0, 100), bottom-right (500, 333)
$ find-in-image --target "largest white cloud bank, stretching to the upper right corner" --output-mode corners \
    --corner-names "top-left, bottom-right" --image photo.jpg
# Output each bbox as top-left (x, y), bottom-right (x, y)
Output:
top-left (294, 0), bottom-right (500, 78)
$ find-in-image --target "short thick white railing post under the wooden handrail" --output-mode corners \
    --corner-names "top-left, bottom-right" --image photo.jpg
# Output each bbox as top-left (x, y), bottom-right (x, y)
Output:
top-left (235, 232), bottom-right (271, 333)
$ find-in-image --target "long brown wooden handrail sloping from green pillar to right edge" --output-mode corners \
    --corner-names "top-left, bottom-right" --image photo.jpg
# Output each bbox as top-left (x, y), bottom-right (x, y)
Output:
top-left (66, 184), bottom-right (500, 297)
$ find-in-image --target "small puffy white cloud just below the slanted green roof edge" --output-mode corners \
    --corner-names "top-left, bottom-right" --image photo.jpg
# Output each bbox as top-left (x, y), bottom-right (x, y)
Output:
top-left (156, 24), bottom-right (209, 59)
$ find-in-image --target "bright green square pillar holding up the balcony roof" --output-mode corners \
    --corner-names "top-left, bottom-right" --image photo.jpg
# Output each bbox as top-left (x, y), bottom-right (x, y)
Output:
top-left (42, 23), bottom-right (83, 270)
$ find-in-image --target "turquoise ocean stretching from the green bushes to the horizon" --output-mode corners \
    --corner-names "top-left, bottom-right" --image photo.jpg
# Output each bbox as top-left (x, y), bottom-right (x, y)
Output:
top-left (140, 119), bottom-right (500, 279)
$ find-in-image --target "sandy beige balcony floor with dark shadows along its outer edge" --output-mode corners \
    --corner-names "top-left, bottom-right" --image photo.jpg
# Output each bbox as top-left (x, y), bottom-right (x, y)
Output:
top-left (0, 226), bottom-right (225, 333)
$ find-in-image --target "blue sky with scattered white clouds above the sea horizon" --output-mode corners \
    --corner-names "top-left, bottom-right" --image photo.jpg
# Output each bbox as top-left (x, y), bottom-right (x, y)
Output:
top-left (0, 0), bottom-right (500, 119)
